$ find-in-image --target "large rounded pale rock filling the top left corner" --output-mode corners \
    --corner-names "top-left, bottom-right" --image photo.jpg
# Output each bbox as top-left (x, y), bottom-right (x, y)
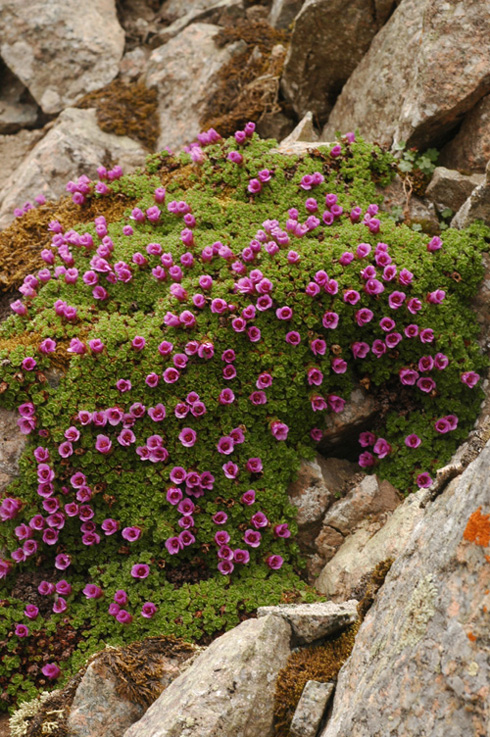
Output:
top-left (0, 0), bottom-right (124, 113)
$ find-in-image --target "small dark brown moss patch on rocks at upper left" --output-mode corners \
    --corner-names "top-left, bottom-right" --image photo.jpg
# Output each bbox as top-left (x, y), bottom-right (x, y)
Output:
top-left (77, 79), bottom-right (160, 151)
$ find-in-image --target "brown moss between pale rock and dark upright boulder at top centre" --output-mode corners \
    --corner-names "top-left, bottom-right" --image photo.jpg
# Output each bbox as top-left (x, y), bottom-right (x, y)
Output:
top-left (200, 20), bottom-right (288, 136)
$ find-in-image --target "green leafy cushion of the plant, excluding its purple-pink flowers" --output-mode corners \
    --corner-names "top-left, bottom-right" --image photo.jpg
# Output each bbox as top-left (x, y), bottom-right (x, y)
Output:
top-left (0, 136), bottom-right (486, 705)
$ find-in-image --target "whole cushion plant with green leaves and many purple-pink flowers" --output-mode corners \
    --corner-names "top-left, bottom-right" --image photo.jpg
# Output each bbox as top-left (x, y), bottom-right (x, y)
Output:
top-left (0, 124), bottom-right (485, 705)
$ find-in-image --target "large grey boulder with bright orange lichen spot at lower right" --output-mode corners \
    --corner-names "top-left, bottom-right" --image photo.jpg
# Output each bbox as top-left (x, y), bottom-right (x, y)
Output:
top-left (322, 443), bottom-right (490, 737)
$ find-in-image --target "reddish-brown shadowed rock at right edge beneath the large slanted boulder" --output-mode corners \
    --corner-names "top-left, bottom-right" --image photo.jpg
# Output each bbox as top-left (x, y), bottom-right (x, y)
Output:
top-left (439, 95), bottom-right (490, 172)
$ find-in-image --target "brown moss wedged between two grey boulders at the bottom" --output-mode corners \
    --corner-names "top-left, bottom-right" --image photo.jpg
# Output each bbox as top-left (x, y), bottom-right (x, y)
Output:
top-left (274, 623), bottom-right (359, 737)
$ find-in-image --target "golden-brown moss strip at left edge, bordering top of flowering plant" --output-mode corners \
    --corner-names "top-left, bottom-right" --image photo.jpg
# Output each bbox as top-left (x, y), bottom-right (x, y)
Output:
top-left (0, 194), bottom-right (134, 291)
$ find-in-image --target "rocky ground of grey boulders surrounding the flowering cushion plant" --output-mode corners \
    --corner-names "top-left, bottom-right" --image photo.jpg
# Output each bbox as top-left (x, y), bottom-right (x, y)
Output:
top-left (0, 0), bottom-right (490, 737)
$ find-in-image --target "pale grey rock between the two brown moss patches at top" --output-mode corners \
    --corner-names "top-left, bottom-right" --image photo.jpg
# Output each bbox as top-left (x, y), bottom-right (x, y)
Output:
top-left (146, 23), bottom-right (244, 149)
